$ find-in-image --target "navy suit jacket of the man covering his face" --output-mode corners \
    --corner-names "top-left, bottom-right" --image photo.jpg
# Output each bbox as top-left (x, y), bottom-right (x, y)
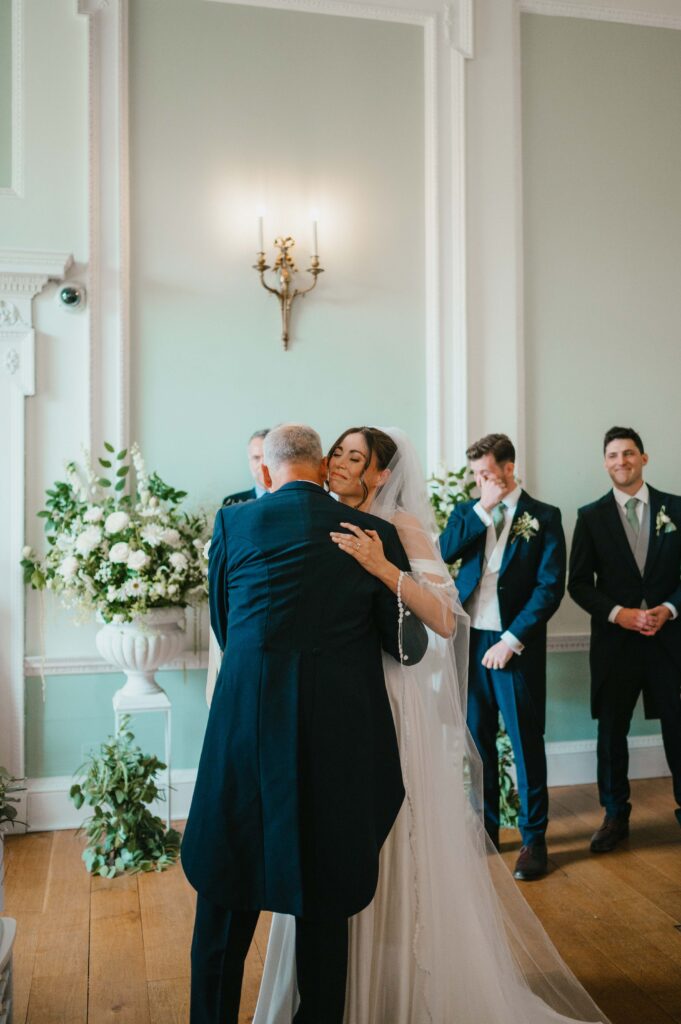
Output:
top-left (439, 490), bottom-right (566, 714)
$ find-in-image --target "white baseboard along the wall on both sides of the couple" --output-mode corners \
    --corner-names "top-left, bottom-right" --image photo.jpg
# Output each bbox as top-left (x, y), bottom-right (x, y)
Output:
top-left (22, 735), bottom-right (670, 831)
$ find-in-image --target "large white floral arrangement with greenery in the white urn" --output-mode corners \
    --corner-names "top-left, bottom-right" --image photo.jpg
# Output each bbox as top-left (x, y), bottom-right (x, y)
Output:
top-left (22, 443), bottom-right (209, 623)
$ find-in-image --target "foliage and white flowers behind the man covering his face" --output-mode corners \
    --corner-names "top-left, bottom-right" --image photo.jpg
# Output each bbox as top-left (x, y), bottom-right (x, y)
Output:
top-left (428, 466), bottom-right (520, 828)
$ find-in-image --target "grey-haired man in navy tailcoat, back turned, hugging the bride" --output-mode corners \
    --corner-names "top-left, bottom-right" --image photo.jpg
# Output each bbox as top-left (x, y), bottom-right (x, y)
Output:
top-left (182, 425), bottom-right (427, 1024)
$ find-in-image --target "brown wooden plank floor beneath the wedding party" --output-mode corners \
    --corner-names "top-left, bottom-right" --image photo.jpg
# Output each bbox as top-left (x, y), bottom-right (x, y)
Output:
top-left (5, 779), bottom-right (681, 1024)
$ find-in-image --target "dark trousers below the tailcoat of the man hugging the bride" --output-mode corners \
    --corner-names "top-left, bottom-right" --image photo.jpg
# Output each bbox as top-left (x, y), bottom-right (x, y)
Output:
top-left (189, 896), bottom-right (347, 1024)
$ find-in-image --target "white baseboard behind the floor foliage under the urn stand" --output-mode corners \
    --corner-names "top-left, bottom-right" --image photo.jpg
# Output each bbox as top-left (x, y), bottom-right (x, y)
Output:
top-left (25, 768), bottom-right (197, 831)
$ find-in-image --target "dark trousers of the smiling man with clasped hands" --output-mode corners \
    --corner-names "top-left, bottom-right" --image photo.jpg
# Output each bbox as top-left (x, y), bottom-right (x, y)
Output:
top-left (598, 627), bottom-right (681, 818)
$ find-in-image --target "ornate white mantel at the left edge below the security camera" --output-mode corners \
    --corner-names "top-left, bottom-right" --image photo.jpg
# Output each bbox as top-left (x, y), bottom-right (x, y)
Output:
top-left (0, 250), bottom-right (73, 775)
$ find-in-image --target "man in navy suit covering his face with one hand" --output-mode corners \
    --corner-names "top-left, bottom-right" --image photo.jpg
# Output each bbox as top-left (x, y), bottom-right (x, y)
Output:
top-left (440, 434), bottom-right (565, 882)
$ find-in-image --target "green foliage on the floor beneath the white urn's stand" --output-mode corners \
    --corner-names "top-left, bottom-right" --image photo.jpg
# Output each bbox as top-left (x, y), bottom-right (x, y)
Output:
top-left (69, 716), bottom-right (180, 879)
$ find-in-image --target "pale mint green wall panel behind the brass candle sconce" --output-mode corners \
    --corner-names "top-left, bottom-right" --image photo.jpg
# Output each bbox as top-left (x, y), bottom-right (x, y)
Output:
top-left (130, 0), bottom-right (426, 506)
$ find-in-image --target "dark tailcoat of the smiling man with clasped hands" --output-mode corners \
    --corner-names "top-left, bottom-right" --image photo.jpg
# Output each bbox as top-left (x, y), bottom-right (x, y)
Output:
top-left (567, 486), bottom-right (681, 718)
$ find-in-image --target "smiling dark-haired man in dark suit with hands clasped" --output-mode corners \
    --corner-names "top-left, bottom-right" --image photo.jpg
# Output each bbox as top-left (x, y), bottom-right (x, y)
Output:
top-left (567, 427), bottom-right (681, 853)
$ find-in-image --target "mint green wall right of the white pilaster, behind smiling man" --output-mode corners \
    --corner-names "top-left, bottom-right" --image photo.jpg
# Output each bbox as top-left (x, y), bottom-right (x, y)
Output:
top-left (521, 14), bottom-right (681, 739)
